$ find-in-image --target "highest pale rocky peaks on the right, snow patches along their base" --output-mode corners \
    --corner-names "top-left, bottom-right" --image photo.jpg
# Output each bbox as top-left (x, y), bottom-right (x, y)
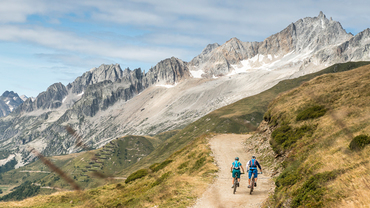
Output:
top-left (188, 12), bottom-right (369, 78)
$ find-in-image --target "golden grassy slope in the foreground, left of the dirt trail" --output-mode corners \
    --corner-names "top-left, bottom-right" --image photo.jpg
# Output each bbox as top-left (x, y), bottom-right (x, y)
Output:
top-left (0, 135), bottom-right (217, 208)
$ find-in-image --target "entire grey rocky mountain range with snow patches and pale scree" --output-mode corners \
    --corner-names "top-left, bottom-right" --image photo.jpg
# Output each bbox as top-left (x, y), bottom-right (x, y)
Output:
top-left (0, 12), bottom-right (370, 167)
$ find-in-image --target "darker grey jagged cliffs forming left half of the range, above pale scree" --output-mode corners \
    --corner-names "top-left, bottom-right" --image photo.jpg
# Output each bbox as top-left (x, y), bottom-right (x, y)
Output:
top-left (0, 57), bottom-right (190, 163)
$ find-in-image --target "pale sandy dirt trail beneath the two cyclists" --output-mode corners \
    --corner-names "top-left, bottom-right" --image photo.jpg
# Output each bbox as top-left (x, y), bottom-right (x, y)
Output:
top-left (193, 134), bottom-right (272, 208)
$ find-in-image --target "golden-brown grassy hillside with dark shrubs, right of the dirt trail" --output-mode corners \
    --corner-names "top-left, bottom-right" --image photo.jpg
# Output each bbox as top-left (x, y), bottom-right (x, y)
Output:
top-left (264, 66), bottom-right (370, 207)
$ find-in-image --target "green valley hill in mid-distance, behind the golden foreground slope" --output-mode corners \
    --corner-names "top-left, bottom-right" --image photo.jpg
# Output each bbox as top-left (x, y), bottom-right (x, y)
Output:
top-left (0, 135), bottom-right (159, 200)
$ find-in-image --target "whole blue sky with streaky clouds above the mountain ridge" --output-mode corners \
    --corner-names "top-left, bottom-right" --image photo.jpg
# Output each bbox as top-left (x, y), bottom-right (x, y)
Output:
top-left (0, 0), bottom-right (370, 97)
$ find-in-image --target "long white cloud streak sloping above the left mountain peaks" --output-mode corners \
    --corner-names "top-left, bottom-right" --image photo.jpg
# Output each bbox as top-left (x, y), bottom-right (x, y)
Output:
top-left (0, 25), bottom-right (191, 62)
